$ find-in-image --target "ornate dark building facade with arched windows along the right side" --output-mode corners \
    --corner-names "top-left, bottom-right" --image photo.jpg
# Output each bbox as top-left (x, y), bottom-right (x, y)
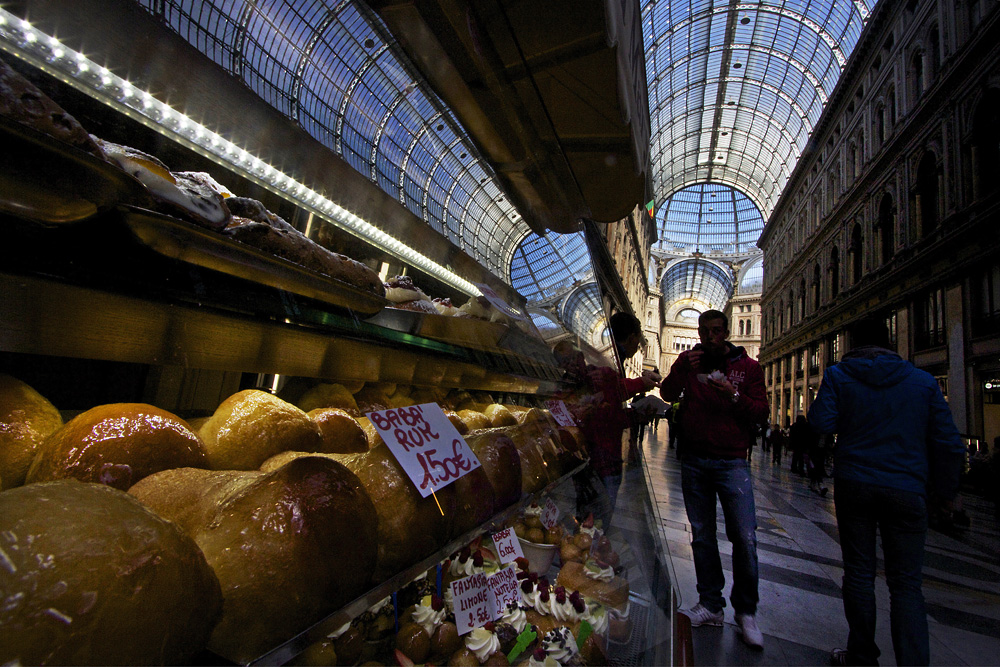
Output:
top-left (759, 0), bottom-right (1000, 441)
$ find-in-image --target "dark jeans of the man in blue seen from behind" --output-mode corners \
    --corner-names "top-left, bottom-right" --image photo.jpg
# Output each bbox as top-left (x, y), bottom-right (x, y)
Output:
top-left (835, 479), bottom-right (930, 665)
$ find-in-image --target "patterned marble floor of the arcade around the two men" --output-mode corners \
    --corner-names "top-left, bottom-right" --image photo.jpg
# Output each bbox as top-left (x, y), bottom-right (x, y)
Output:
top-left (643, 424), bottom-right (1000, 665)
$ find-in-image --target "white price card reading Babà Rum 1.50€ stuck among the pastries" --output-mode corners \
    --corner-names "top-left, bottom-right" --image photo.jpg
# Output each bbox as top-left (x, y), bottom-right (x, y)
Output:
top-left (366, 403), bottom-right (480, 498)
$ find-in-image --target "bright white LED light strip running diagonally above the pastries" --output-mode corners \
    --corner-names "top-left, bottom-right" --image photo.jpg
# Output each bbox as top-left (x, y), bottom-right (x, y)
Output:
top-left (0, 9), bottom-right (481, 296)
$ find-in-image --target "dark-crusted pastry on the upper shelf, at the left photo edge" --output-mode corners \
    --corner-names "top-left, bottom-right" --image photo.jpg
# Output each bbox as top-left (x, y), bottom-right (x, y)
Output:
top-left (0, 59), bottom-right (107, 160)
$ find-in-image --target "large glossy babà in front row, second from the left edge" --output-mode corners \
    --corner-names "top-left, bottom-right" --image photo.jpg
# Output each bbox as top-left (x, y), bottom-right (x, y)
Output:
top-left (130, 455), bottom-right (378, 663)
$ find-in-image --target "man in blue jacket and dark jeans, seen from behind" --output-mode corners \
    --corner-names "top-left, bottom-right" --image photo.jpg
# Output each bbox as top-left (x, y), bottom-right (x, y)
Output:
top-left (809, 319), bottom-right (964, 665)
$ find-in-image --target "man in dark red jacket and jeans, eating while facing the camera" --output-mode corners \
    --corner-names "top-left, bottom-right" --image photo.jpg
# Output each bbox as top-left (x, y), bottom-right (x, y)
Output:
top-left (660, 310), bottom-right (768, 649)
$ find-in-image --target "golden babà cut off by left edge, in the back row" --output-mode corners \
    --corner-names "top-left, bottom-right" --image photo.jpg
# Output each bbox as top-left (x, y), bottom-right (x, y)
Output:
top-left (0, 376), bottom-right (63, 489)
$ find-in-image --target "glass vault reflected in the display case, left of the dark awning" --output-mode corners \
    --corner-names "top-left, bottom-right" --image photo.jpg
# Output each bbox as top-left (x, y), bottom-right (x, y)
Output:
top-left (138, 0), bottom-right (529, 280)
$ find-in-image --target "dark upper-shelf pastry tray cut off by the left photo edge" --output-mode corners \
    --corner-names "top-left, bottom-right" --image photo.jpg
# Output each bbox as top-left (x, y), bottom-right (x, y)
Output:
top-left (0, 118), bottom-right (149, 225)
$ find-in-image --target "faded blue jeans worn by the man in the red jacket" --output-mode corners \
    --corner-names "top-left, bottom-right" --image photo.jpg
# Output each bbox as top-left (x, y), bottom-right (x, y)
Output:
top-left (681, 454), bottom-right (760, 614)
